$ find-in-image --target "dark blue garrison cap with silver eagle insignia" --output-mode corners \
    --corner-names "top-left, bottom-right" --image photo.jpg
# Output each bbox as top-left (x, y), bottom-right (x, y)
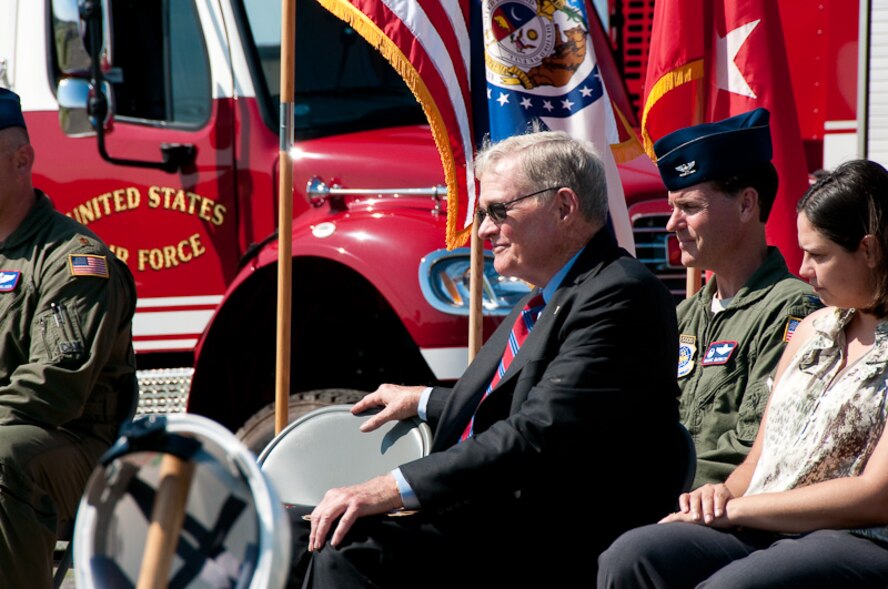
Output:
top-left (654, 108), bottom-right (773, 190)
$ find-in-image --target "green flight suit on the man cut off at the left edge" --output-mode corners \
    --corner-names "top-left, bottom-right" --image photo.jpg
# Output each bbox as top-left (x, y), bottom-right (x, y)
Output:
top-left (0, 191), bottom-right (136, 588)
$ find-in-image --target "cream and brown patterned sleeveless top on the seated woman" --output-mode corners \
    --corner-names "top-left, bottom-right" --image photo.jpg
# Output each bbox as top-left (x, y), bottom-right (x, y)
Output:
top-left (746, 309), bottom-right (888, 541)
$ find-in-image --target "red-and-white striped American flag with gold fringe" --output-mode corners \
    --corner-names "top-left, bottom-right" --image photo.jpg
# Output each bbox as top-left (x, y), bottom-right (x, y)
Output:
top-left (318, 0), bottom-right (475, 249)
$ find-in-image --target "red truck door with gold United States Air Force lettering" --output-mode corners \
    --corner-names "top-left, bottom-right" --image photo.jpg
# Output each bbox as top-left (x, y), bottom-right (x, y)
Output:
top-left (36, 0), bottom-right (240, 352)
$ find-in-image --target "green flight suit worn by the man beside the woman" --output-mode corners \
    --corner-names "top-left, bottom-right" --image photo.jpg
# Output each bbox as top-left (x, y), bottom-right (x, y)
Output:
top-left (677, 247), bottom-right (822, 488)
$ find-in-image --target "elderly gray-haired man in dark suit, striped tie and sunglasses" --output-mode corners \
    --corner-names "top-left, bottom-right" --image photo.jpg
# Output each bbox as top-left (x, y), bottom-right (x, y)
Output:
top-left (292, 132), bottom-right (687, 587)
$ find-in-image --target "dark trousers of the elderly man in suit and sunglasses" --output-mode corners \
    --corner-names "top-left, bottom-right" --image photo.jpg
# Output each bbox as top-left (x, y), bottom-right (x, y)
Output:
top-left (288, 500), bottom-right (597, 589)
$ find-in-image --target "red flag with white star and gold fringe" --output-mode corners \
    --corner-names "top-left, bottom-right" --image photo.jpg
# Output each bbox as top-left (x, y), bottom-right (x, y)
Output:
top-left (641, 0), bottom-right (808, 271)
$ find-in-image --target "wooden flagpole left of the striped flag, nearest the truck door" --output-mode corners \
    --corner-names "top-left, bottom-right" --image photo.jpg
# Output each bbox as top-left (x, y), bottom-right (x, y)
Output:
top-left (274, 0), bottom-right (296, 434)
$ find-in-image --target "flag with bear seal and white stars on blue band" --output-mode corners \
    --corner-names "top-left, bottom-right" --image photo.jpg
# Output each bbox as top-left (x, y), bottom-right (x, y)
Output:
top-left (482, 0), bottom-right (635, 251)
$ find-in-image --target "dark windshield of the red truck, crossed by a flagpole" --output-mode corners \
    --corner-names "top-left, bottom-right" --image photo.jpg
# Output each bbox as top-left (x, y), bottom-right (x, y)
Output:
top-left (243, 0), bottom-right (425, 138)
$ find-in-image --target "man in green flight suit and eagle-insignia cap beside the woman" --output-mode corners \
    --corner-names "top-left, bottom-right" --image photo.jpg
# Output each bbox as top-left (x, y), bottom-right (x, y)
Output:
top-left (654, 108), bottom-right (821, 488)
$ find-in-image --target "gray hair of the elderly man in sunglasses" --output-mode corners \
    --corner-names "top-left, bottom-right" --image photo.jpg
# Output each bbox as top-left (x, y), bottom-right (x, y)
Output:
top-left (475, 131), bottom-right (608, 223)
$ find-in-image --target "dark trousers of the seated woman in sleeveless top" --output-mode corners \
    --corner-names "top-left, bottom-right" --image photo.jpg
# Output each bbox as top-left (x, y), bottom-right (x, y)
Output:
top-left (598, 523), bottom-right (888, 589)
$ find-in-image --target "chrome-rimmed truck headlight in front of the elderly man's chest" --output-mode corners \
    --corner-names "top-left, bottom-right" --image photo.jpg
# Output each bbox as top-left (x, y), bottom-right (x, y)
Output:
top-left (419, 247), bottom-right (530, 315)
